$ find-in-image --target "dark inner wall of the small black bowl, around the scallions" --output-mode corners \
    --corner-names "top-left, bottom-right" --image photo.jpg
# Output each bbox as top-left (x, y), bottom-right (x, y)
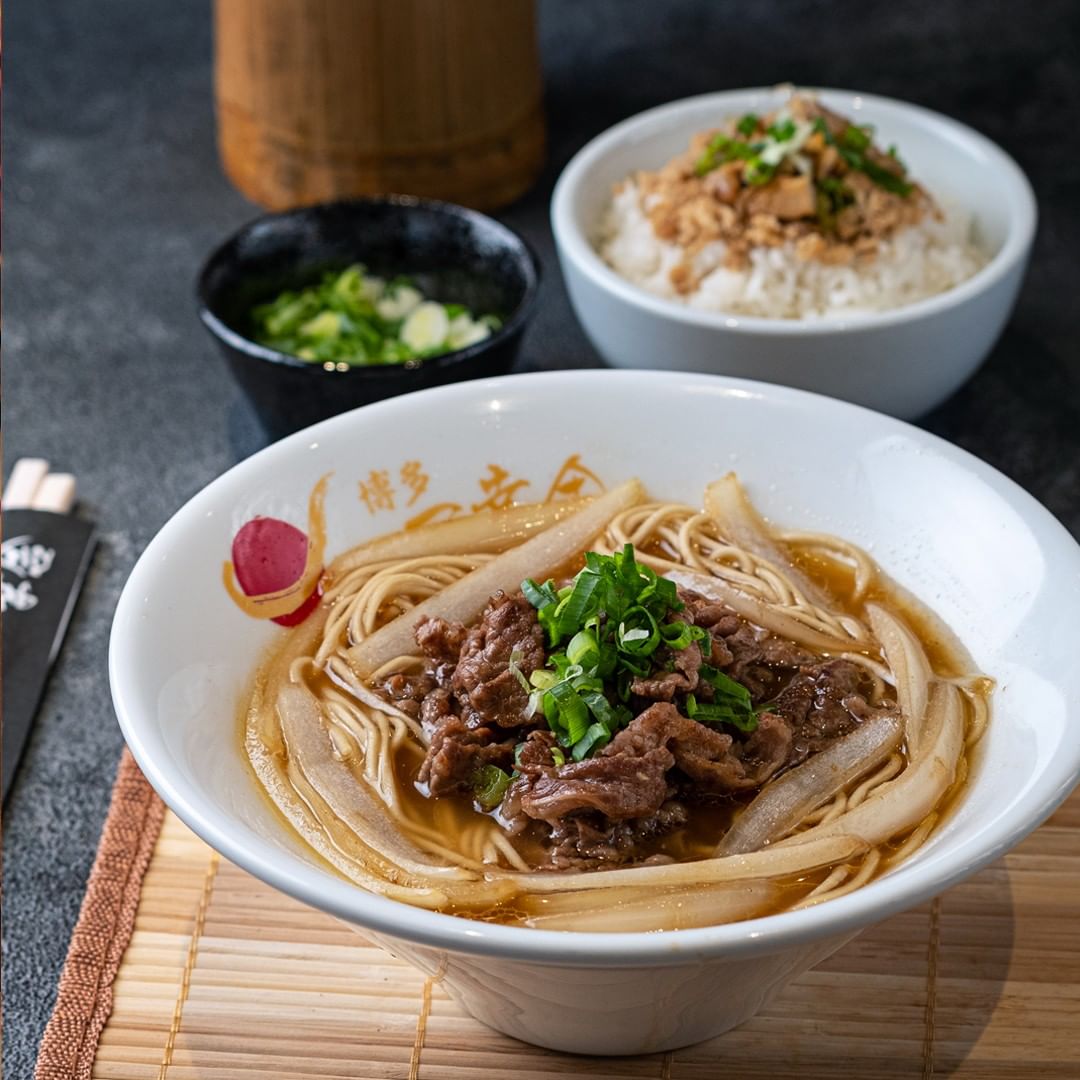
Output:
top-left (199, 197), bottom-right (538, 362)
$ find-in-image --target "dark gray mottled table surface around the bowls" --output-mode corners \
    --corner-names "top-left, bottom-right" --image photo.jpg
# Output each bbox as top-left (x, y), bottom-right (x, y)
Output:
top-left (3, 0), bottom-right (1080, 1078)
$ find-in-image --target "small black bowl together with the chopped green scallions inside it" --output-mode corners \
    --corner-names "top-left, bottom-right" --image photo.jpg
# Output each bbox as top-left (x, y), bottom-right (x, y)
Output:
top-left (198, 195), bottom-right (540, 438)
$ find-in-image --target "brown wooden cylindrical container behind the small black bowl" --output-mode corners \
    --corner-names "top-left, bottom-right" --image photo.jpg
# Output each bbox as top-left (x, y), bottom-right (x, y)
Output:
top-left (215, 0), bottom-right (544, 210)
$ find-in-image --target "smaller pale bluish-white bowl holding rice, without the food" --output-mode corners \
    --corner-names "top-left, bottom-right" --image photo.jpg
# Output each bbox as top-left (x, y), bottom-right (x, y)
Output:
top-left (551, 87), bottom-right (1036, 418)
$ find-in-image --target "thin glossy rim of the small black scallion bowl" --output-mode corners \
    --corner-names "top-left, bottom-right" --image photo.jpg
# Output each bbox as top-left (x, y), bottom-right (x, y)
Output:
top-left (195, 194), bottom-right (541, 379)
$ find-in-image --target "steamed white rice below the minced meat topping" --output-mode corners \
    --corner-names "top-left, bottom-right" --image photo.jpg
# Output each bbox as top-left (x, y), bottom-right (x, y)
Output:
top-left (597, 179), bottom-right (987, 319)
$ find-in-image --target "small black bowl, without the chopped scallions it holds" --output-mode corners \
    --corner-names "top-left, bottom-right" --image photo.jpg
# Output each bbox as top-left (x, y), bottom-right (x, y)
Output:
top-left (198, 195), bottom-right (540, 438)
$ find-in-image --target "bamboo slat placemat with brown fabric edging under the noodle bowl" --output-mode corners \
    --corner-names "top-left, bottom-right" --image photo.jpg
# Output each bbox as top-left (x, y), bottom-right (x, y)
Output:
top-left (37, 754), bottom-right (1080, 1080)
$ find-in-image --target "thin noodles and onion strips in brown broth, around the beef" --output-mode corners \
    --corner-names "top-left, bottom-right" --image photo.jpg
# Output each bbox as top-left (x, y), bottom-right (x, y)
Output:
top-left (245, 476), bottom-right (991, 931)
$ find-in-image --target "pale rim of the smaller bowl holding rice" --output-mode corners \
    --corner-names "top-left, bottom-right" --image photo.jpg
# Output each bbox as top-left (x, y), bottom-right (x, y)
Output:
top-left (551, 86), bottom-right (1038, 337)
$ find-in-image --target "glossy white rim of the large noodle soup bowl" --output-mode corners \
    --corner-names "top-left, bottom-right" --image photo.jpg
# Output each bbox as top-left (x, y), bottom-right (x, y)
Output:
top-left (109, 370), bottom-right (1080, 968)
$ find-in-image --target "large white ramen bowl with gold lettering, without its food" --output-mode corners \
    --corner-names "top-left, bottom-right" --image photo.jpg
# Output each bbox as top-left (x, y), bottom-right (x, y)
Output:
top-left (109, 372), bottom-right (1080, 1054)
